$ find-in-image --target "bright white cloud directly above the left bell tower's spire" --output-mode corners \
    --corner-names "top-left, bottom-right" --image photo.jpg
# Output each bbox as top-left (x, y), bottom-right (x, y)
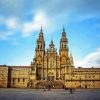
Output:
top-left (22, 11), bottom-right (50, 36)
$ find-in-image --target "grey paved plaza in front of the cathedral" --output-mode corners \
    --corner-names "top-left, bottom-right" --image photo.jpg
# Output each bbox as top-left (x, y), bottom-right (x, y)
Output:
top-left (0, 89), bottom-right (100, 100)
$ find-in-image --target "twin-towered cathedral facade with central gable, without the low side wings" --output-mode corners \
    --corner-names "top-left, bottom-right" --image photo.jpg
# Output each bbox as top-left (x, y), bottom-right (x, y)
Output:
top-left (31, 26), bottom-right (74, 81)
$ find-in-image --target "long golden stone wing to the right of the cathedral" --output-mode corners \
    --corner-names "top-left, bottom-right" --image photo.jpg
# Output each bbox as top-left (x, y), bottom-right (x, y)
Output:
top-left (65, 67), bottom-right (100, 88)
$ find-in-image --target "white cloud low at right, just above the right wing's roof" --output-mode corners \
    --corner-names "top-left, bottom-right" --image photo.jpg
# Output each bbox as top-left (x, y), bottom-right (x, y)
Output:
top-left (75, 48), bottom-right (100, 67)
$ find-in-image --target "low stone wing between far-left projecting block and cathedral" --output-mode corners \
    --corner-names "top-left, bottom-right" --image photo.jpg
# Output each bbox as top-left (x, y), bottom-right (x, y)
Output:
top-left (8, 66), bottom-right (31, 88)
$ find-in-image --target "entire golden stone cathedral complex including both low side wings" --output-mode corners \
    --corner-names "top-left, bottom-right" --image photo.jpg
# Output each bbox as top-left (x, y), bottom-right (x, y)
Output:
top-left (0, 27), bottom-right (100, 89)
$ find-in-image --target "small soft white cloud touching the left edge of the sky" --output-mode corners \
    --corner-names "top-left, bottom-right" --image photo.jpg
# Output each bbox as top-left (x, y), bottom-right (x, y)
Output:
top-left (0, 16), bottom-right (20, 40)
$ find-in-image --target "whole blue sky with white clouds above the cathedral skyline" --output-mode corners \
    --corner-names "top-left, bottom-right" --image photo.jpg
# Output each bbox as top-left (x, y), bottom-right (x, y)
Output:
top-left (0, 0), bottom-right (100, 67)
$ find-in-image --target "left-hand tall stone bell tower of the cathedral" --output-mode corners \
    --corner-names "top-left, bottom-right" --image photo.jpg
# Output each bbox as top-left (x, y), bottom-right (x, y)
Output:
top-left (35, 26), bottom-right (45, 80)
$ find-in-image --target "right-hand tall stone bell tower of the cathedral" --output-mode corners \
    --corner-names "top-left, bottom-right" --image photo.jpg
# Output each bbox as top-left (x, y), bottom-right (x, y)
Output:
top-left (59, 27), bottom-right (69, 80)
